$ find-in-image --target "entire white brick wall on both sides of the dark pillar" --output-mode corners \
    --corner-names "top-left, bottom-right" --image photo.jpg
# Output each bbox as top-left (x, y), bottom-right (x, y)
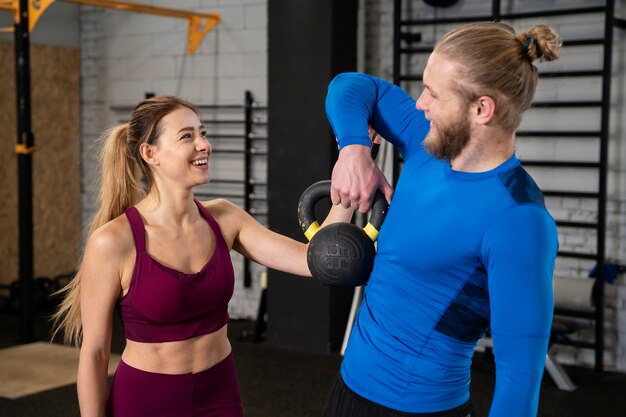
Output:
top-left (64, 0), bottom-right (626, 360)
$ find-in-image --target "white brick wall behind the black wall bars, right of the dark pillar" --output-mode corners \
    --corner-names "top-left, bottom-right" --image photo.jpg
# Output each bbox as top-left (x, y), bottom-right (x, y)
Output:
top-left (362, 0), bottom-right (626, 371)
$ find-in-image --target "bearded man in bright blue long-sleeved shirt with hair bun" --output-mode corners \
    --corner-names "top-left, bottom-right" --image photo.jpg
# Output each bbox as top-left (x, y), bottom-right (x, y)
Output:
top-left (324, 23), bottom-right (561, 417)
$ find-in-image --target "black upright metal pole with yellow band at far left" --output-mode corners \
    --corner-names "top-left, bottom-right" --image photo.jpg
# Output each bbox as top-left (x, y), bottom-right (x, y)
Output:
top-left (14, 0), bottom-right (34, 343)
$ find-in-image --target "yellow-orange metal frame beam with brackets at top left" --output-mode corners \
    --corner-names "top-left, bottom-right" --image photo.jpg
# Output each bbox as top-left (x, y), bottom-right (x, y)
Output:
top-left (0, 0), bottom-right (221, 54)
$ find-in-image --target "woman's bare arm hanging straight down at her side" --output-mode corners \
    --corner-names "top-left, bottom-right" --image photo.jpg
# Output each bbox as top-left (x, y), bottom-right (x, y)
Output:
top-left (77, 225), bottom-right (123, 417)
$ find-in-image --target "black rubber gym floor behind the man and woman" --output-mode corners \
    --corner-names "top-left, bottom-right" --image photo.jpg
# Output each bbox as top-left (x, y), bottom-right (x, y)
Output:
top-left (0, 314), bottom-right (626, 417)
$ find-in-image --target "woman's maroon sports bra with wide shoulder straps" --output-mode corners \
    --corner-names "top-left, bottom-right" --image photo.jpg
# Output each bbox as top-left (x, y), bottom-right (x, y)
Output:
top-left (118, 200), bottom-right (235, 343)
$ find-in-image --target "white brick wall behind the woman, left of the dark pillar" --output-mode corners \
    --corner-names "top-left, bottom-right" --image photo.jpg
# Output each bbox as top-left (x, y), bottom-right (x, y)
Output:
top-left (80, 0), bottom-right (266, 318)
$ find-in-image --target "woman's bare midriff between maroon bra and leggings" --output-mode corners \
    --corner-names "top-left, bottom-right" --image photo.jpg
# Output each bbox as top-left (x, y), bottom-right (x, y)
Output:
top-left (122, 325), bottom-right (231, 375)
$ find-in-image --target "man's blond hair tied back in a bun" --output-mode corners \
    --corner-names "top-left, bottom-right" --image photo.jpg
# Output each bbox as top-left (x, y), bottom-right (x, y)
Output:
top-left (433, 22), bottom-right (562, 132)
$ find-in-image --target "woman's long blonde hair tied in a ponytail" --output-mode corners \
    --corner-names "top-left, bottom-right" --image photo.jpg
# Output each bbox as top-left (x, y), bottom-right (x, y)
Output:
top-left (52, 96), bottom-right (199, 346)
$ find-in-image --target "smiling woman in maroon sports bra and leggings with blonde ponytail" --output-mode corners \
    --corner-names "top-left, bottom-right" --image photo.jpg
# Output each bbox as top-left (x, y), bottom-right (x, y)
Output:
top-left (55, 97), bottom-right (351, 417)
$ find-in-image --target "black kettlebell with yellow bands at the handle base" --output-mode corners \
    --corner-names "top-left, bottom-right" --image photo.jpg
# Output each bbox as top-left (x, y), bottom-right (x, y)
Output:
top-left (298, 180), bottom-right (389, 287)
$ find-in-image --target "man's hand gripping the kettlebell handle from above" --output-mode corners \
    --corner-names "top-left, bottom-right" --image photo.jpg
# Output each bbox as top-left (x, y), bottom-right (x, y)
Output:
top-left (330, 145), bottom-right (393, 213)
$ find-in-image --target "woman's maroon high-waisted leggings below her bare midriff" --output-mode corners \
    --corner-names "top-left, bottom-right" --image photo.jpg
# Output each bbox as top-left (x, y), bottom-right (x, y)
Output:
top-left (106, 352), bottom-right (243, 417)
